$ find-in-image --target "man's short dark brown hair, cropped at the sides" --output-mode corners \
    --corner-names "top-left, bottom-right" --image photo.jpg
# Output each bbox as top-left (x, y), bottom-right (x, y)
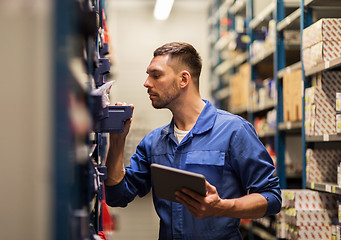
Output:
top-left (154, 42), bottom-right (202, 89)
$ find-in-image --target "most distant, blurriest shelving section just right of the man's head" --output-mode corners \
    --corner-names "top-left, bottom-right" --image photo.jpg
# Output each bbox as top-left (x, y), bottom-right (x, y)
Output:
top-left (209, 0), bottom-right (248, 108)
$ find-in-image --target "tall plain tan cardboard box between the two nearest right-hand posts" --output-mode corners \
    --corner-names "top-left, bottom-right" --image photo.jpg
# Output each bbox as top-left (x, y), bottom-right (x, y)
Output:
top-left (283, 70), bottom-right (302, 122)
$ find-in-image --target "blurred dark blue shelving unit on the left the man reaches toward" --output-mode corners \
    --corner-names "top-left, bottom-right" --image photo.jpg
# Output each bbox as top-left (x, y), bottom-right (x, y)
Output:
top-left (52, 0), bottom-right (121, 240)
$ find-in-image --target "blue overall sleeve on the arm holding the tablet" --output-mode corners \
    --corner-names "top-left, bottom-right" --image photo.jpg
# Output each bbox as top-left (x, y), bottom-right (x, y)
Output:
top-left (230, 121), bottom-right (282, 216)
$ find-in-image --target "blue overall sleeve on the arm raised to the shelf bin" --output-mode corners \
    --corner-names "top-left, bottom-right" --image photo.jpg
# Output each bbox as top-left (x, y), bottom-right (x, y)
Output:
top-left (105, 138), bottom-right (151, 207)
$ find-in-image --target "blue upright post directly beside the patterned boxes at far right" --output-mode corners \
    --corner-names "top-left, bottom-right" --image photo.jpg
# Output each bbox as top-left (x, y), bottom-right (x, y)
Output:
top-left (300, 0), bottom-right (312, 189)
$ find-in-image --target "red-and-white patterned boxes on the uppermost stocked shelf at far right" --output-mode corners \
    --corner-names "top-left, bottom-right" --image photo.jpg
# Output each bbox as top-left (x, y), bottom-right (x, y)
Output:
top-left (302, 18), bottom-right (341, 69)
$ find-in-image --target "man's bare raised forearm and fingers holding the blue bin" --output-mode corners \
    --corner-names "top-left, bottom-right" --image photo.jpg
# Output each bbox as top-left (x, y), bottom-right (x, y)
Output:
top-left (104, 103), bottom-right (134, 186)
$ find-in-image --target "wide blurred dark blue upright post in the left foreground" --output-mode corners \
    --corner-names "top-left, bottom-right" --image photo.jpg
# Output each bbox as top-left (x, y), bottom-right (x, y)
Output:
top-left (52, 0), bottom-right (77, 240)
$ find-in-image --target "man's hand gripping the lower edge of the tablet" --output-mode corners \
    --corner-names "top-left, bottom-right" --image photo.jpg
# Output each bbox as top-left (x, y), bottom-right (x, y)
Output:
top-left (175, 181), bottom-right (221, 219)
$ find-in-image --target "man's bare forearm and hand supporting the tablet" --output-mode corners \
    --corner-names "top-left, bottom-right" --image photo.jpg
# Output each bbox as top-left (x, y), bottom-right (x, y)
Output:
top-left (176, 181), bottom-right (268, 219)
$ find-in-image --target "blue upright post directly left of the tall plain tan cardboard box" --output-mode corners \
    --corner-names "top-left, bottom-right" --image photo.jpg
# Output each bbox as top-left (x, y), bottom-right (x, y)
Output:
top-left (274, 0), bottom-right (287, 189)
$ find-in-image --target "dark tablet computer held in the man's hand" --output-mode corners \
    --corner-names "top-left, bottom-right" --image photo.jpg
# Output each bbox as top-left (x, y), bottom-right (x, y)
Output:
top-left (150, 163), bottom-right (206, 202)
